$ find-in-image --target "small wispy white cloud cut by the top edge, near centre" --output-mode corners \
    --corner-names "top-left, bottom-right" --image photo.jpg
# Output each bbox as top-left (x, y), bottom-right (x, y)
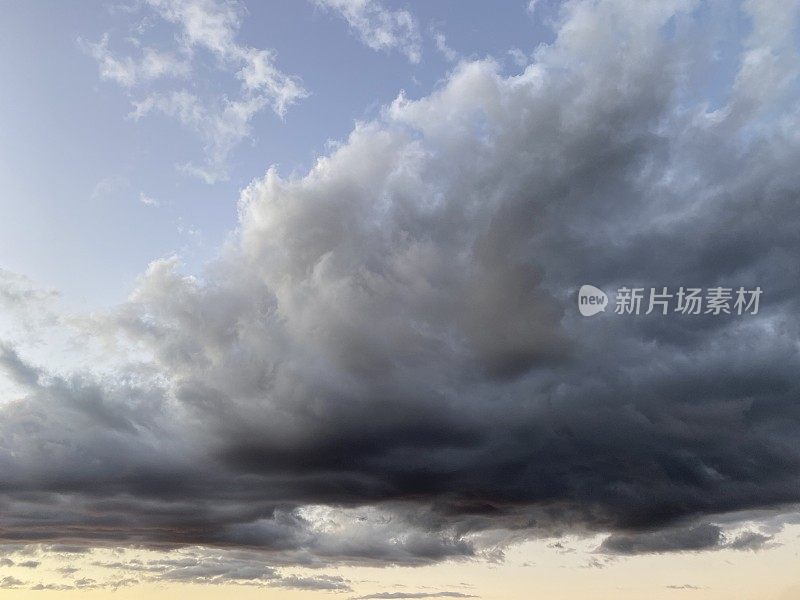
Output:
top-left (315, 0), bottom-right (422, 63)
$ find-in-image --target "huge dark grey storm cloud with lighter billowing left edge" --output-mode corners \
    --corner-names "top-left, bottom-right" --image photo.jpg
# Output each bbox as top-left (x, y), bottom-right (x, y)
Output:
top-left (0, 1), bottom-right (800, 580)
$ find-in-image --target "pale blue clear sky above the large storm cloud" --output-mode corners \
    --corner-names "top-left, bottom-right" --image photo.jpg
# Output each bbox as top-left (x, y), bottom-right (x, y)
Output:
top-left (0, 0), bottom-right (556, 306)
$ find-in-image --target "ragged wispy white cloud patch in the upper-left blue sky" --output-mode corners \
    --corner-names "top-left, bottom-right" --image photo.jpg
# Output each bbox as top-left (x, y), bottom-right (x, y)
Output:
top-left (79, 0), bottom-right (308, 184)
